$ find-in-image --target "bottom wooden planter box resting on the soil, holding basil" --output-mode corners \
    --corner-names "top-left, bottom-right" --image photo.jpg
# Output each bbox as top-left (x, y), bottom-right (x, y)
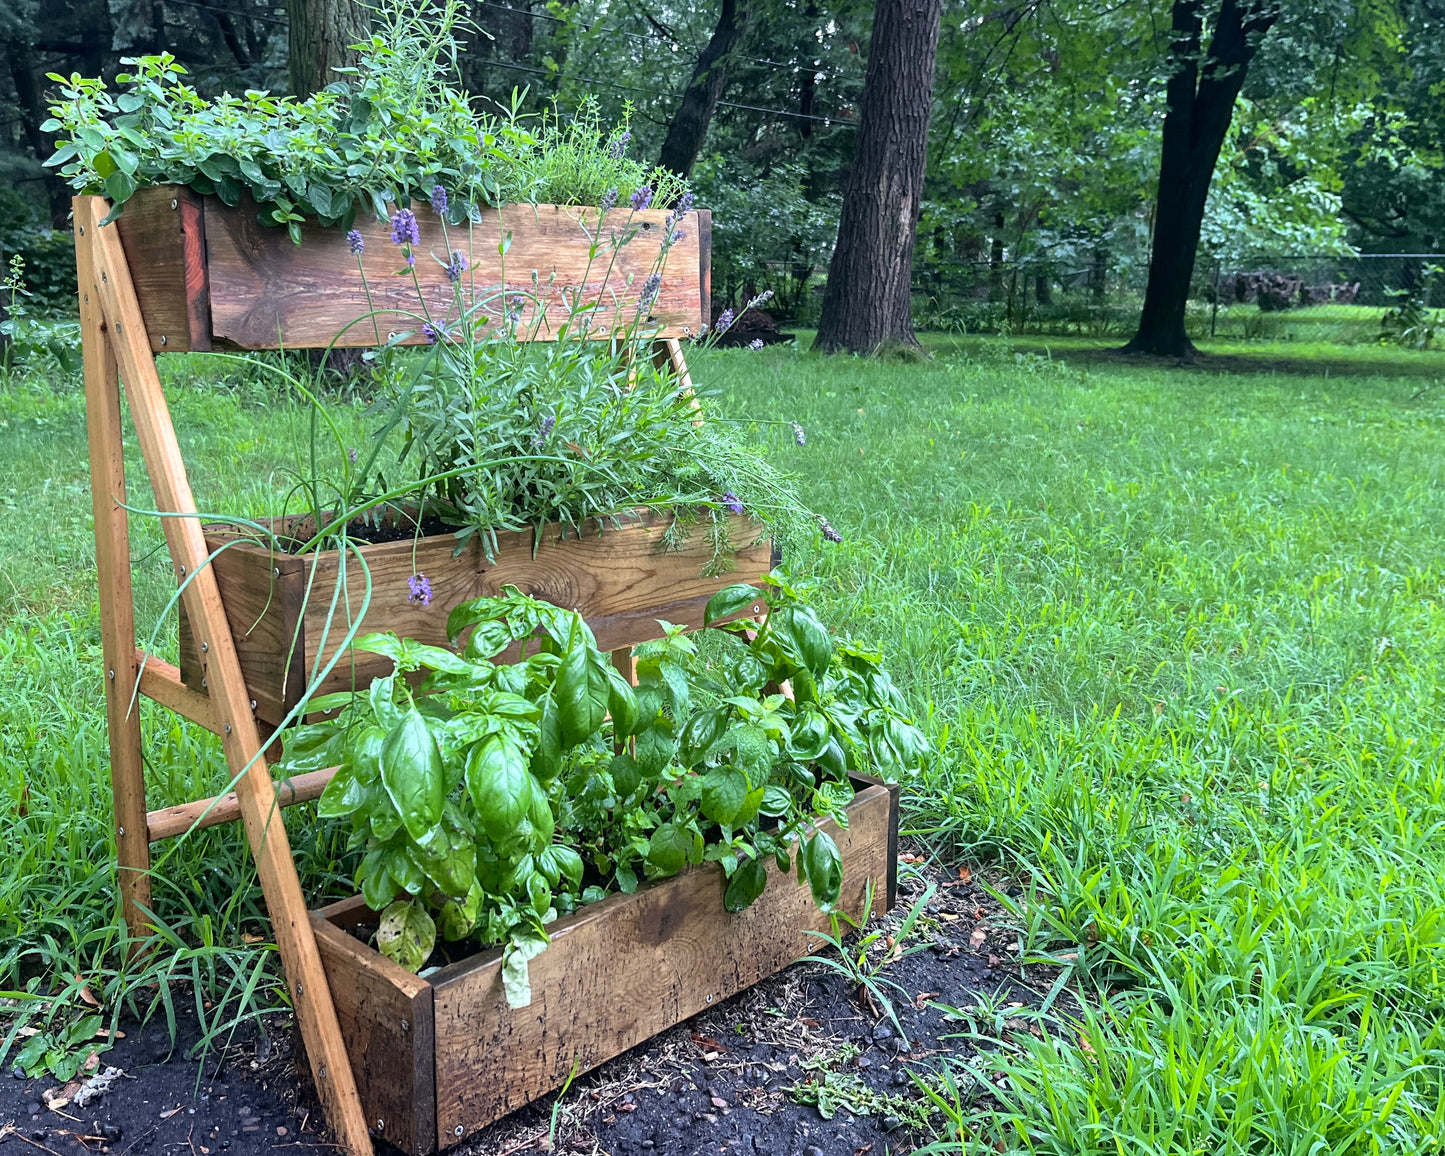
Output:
top-left (311, 777), bottom-right (897, 1156)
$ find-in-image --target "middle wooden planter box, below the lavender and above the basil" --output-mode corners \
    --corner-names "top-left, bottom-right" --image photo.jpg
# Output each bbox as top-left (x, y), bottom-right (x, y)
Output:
top-left (181, 512), bottom-right (775, 725)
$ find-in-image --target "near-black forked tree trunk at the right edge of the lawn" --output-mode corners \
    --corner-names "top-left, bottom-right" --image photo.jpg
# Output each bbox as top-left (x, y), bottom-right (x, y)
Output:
top-left (1124, 0), bottom-right (1279, 358)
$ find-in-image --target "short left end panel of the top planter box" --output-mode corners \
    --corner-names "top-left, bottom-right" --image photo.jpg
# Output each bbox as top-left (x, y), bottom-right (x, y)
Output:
top-left (107, 185), bottom-right (199, 353)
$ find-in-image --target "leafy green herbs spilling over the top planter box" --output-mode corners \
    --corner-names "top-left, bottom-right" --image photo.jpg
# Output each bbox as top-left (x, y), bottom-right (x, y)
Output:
top-left (45, 0), bottom-right (682, 241)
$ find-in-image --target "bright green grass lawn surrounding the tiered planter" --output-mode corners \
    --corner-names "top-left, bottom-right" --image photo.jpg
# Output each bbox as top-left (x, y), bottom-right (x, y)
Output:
top-left (0, 338), bottom-right (1445, 1156)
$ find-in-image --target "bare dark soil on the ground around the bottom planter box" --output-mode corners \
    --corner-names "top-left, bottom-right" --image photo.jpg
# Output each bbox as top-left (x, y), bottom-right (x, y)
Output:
top-left (0, 873), bottom-right (1077, 1156)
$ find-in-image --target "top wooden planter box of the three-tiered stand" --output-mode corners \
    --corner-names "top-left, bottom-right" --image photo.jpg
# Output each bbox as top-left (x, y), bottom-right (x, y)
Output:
top-left (116, 186), bottom-right (712, 353)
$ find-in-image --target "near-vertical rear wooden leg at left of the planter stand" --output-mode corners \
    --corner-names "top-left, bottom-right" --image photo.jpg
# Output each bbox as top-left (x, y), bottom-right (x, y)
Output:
top-left (75, 212), bottom-right (150, 948)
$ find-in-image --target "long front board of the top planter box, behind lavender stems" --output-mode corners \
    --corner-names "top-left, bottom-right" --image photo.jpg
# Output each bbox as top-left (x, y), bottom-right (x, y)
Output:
top-left (195, 199), bottom-right (702, 350)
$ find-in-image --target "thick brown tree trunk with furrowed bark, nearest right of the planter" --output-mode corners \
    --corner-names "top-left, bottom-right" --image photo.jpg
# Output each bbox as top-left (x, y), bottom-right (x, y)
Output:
top-left (814, 0), bottom-right (942, 353)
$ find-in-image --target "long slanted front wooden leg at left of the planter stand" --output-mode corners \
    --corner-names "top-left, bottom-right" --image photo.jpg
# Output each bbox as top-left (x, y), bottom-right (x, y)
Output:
top-left (74, 197), bottom-right (371, 1156)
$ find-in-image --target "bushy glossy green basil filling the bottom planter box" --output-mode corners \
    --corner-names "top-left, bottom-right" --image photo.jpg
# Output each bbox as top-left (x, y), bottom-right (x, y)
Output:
top-left (279, 575), bottom-right (929, 1007)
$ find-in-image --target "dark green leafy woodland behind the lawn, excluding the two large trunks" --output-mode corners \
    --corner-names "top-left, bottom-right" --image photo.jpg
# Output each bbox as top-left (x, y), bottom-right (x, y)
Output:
top-left (0, 0), bottom-right (1445, 332)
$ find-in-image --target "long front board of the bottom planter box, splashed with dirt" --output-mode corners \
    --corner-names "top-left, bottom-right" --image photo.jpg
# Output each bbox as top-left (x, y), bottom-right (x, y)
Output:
top-left (421, 786), bottom-right (893, 1146)
